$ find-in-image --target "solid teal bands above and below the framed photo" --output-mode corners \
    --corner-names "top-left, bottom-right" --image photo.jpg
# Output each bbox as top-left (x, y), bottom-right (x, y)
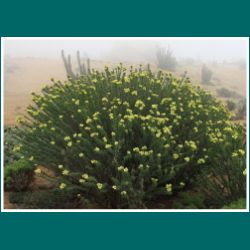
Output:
top-left (0, 0), bottom-right (250, 250)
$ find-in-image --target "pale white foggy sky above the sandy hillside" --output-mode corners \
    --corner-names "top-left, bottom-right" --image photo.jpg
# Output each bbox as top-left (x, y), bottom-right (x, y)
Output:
top-left (4, 38), bottom-right (247, 61)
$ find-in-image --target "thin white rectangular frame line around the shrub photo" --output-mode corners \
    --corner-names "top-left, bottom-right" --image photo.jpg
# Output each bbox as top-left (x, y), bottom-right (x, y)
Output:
top-left (1, 37), bottom-right (249, 212)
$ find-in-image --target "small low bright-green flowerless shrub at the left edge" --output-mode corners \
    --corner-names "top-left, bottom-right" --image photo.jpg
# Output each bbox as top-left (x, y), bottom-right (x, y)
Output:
top-left (4, 160), bottom-right (34, 191)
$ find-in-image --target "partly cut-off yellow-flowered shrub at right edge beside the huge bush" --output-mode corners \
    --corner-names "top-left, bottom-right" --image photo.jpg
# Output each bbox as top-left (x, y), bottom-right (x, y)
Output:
top-left (195, 124), bottom-right (246, 208)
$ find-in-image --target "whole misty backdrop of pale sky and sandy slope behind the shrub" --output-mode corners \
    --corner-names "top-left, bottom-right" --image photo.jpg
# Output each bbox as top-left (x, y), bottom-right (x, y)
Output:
top-left (2, 38), bottom-right (248, 125)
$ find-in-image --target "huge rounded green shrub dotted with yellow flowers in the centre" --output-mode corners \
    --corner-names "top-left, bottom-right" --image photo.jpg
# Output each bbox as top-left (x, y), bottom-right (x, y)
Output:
top-left (13, 66), bottom-right (244, 208)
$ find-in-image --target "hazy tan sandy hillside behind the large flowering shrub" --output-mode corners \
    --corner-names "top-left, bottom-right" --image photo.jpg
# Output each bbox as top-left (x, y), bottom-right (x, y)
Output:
top-left (4, 57), bottom-right (246, 125)
